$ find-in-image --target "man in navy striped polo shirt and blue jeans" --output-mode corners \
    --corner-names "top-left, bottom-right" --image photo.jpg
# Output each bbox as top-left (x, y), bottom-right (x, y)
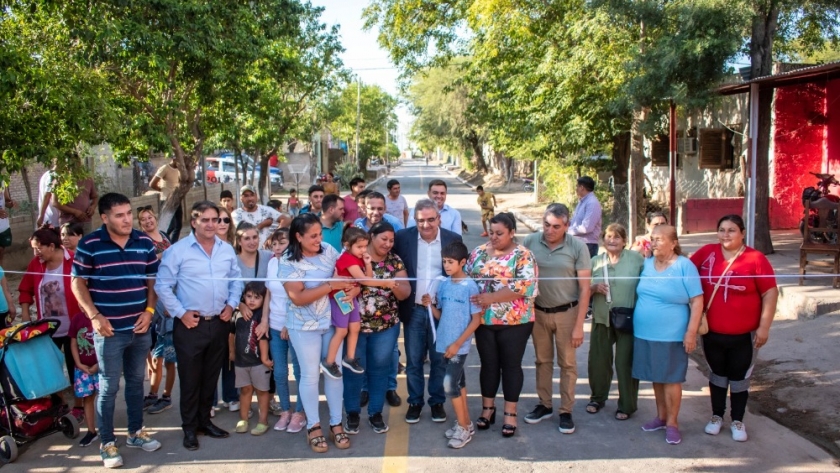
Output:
top-left (71, 193), bottom-right (160, 468)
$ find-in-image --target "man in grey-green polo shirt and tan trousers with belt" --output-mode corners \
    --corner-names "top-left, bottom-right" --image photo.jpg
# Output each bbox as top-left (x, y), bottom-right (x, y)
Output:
top-left (523, 204), bottom-right (592, 434)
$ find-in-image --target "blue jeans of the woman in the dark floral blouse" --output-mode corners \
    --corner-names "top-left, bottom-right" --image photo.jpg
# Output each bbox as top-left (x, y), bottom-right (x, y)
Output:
top-left (344, 324), bottom-right (400, 415)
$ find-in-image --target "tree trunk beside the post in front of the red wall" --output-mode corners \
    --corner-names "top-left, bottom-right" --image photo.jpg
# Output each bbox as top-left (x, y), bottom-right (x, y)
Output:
top-left (748, 1), bottom-right (779, 254)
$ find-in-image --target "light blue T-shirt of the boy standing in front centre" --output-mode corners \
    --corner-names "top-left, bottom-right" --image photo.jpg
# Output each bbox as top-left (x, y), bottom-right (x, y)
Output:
top-left (435, 277), bottom-right (484, 355)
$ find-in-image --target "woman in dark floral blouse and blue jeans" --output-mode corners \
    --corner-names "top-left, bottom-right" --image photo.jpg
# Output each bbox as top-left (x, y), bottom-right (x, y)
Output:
top-left (344, 221), bottom-right (411, 434)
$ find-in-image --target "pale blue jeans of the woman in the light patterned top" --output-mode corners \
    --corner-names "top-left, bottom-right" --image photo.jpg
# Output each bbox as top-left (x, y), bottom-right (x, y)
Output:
top-left (289, 327), bottom-right (344, 429)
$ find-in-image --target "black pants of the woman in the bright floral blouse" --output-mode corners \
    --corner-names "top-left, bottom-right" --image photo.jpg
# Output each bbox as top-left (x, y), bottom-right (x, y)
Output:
top-left (475, 323), bottom-right (534, 402)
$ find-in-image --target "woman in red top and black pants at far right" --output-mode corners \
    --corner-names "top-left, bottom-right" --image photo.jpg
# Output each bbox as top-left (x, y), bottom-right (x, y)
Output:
top-left (691, 215), bottom-right (779, 442)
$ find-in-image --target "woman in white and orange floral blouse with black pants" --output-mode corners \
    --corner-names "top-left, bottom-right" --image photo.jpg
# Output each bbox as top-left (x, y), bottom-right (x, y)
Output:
top-left (464, 213), bottom-right (537, 437)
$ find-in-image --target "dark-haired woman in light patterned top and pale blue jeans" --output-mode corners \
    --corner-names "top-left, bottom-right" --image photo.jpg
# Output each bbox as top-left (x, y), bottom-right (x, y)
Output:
top-left (280, 213), bottom-right (358, 453)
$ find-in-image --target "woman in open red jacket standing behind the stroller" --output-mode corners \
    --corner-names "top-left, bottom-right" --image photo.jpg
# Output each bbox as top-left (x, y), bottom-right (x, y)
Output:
top-left (18, 227), bottom-right (84, 418)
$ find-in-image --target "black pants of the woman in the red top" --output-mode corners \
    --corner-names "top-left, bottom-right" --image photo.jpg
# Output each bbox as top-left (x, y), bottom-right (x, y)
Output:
top-left (703, 332), bottom-right (754, 421)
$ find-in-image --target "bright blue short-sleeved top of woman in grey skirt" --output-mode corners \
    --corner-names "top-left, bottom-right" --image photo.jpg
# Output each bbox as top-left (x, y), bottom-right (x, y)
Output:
top-left (633, 256), bottom-right (703, 342)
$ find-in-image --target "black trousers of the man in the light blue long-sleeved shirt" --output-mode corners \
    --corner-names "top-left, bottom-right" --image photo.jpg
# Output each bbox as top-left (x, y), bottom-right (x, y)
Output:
top-left (172, 317), bottom-right (230, 431)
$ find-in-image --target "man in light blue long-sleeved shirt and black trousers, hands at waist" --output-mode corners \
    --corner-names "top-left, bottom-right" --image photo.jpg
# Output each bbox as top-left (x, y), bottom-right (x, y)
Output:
top-left (155, 201), bottom-right (242, 450)
